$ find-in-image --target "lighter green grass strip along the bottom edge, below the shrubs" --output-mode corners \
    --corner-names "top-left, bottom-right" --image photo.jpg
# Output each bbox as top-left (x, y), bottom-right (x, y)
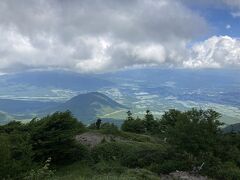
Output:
top-left (52, 162), bottom-right (159, 180)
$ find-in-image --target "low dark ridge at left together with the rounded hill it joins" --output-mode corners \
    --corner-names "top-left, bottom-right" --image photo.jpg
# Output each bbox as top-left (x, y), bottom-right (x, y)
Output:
top-left (0, 92), bottom-right (127, 123)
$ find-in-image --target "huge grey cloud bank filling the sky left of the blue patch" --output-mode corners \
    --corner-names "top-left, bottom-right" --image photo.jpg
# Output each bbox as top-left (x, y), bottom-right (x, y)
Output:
top-left (0, 0), bottom-right (208, 72)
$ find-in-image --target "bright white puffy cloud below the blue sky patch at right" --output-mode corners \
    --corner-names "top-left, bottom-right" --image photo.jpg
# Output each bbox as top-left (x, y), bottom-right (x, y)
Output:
top-left (183, 36), bottom-right (240, 68)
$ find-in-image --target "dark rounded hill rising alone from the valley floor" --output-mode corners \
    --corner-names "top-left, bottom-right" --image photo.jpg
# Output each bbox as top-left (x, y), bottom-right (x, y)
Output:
top-left (42, 92), bottom-right (126, 123)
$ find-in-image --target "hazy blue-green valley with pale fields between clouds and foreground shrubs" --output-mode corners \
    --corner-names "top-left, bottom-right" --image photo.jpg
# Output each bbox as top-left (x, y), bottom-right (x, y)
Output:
top-left (0, 68), bottom-right (240, 124)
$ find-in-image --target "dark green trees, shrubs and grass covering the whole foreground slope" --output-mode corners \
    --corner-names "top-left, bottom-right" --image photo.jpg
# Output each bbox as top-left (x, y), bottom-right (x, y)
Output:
top-left (0, 109), bottom-right (240, 180)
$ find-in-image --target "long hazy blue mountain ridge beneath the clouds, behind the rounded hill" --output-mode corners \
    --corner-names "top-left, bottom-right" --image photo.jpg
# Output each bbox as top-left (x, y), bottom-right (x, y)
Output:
top-left (1, 71), bottom-right (113, 91)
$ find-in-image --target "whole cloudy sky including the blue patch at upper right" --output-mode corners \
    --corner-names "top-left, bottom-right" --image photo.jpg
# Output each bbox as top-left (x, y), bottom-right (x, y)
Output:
top-left (0, 0), bottom-right (240, 73)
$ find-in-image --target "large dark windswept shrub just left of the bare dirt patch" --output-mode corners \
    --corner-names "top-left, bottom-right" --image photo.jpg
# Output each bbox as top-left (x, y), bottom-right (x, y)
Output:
top-left (30, 111), bottom-right (87, 164)
